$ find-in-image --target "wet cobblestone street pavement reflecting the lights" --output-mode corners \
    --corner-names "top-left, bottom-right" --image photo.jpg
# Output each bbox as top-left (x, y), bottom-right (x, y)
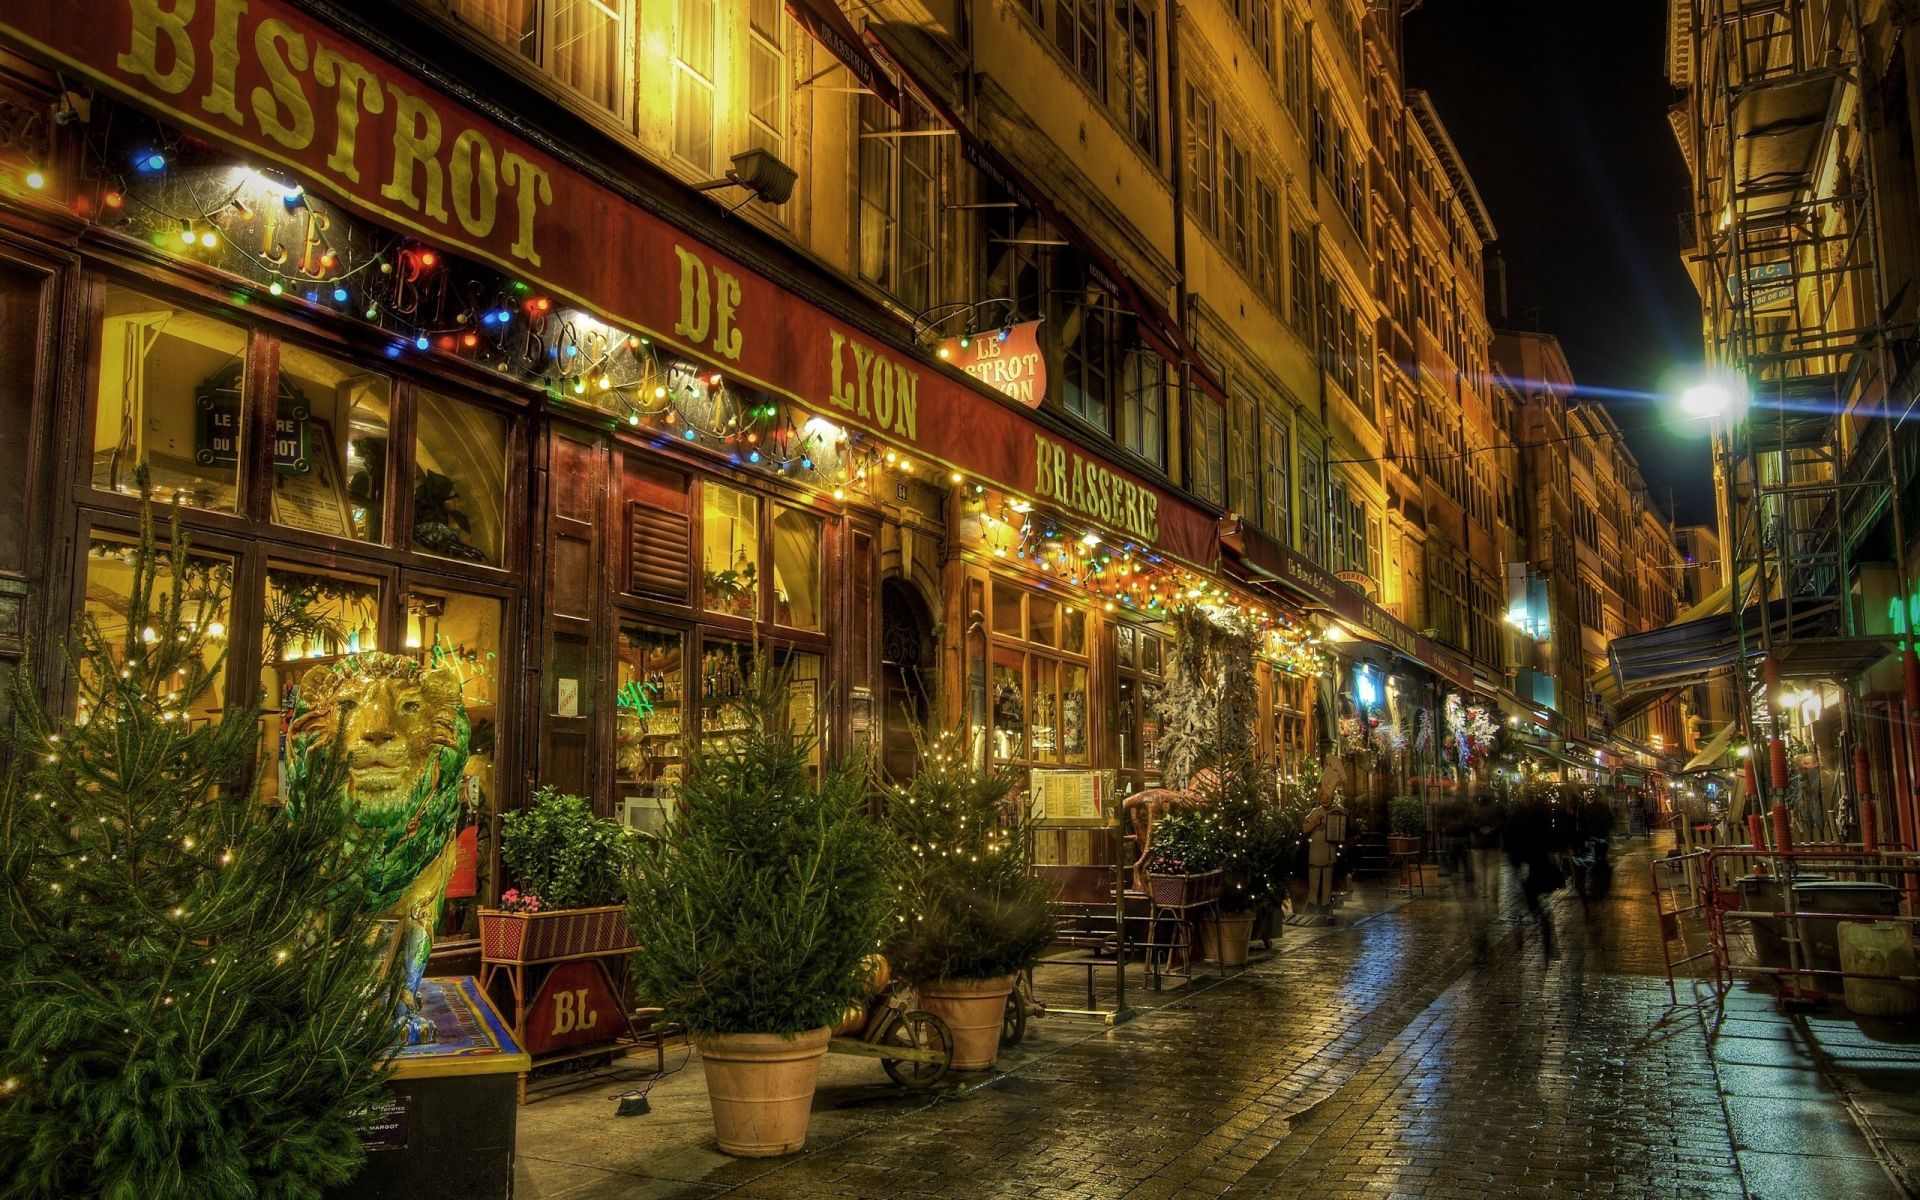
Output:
top-left (518, 851), bottom-right (1910, 1200)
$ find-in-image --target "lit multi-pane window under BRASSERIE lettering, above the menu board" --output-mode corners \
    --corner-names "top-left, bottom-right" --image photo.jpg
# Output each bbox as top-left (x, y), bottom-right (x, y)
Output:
top-left (987, 580), bottom-right (1091, 766)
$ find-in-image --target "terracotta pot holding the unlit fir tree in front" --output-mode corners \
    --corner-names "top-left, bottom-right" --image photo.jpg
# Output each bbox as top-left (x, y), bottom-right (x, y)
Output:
top-left (693, 1025), bottom-right (828, 1158)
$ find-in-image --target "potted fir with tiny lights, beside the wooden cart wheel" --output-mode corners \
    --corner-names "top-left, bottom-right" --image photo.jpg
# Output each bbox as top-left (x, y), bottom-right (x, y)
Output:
top-left (885, 733), bottom-right (1054, 1071)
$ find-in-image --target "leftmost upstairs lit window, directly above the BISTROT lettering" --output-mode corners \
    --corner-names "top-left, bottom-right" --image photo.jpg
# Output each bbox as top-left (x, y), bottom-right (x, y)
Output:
top-left (453, 0), bottom-right (628, 113)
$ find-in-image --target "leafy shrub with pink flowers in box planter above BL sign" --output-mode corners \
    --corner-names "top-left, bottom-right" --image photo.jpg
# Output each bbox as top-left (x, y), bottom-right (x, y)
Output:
top-left (480, 787), bottom-right (637, 962)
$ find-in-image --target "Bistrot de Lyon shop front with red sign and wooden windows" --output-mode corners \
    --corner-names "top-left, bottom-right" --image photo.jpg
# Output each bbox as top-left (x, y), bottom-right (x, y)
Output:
top-left (0, 0), bottom-right (1228, 948)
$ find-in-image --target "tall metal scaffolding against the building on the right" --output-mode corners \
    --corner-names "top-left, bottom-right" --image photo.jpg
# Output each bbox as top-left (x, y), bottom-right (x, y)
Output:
top-left (1676, 0), bottom-right (1910, 837)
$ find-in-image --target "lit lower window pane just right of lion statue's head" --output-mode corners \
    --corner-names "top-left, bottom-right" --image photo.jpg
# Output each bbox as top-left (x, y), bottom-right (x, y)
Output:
top-left (405, 589), bottom-right (501, 937)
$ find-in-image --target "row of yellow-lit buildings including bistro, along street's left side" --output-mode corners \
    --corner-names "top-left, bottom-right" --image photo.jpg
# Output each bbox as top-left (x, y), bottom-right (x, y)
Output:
top-left (0, 0), bottom-right (1597, 963)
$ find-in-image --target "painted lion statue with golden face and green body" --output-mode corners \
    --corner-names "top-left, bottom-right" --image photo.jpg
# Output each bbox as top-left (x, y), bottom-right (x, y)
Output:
top-left (290, 653), bottom-right (467, 1046)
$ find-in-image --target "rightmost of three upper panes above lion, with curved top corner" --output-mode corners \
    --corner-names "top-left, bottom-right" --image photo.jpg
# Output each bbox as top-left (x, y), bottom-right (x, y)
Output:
top-left (413, 392), bottom-right (507, 566)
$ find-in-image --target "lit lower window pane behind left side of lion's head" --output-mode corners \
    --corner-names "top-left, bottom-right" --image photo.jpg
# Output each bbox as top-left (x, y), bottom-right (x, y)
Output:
top-left (259, 563), bottom-right (382, 803)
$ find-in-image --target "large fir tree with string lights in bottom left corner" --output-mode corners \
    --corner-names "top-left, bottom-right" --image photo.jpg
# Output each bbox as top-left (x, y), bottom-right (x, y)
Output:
top-left (0, 468), bottom-right (399, 1200)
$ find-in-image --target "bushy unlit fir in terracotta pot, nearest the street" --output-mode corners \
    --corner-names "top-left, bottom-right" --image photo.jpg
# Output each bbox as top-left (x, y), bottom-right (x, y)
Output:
top-left (628, 662), bottom-right (893, 1158)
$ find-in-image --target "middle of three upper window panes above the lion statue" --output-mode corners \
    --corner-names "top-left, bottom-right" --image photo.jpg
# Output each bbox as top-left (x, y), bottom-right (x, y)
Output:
top-left (273, 344), bottom-right (392, 541)
